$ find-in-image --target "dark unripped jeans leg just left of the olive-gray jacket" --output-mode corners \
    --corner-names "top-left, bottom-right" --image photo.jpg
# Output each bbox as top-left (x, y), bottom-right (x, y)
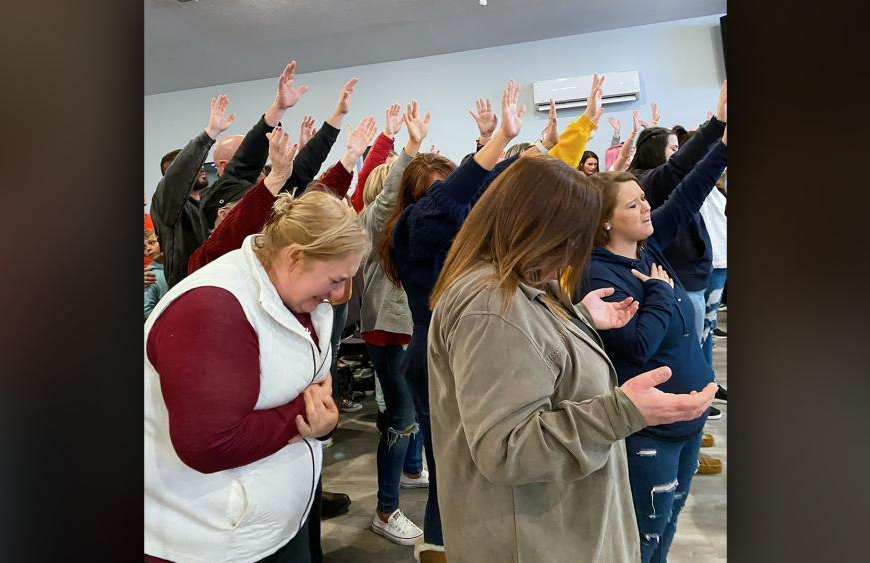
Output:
top-left (405, 330), bottom-right (444, 545)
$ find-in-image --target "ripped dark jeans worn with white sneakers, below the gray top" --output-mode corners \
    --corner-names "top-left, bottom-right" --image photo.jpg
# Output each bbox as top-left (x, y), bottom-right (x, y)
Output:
top-left (366, 344), bottom-right (423, 514)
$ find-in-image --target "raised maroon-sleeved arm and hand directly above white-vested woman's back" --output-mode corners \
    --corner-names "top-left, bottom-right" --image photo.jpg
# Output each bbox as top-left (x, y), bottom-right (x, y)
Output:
top-left (187, 127), bottom-right (296, 274)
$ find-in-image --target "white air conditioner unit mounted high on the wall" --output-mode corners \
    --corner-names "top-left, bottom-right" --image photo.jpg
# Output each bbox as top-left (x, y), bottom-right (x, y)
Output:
top-left (534, 70), bottom-right (640, 111)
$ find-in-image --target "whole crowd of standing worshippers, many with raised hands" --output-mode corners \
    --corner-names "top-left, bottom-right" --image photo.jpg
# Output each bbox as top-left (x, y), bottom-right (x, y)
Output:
top-left (144, 61), bottom-right (727, 563)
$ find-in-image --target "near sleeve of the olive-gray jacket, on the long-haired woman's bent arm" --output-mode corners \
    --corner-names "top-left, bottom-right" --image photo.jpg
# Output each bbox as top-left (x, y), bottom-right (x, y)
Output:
top-left (450, 314), bottom-right (644, 485)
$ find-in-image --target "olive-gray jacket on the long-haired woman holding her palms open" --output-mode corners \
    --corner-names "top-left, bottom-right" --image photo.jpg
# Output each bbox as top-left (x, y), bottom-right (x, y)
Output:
top-left (428, 266), bottom-right (645, 563)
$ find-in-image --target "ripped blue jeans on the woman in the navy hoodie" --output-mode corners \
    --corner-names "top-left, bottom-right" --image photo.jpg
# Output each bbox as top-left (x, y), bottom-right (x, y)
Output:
top-left (625, 431), bottom-right (703, 563)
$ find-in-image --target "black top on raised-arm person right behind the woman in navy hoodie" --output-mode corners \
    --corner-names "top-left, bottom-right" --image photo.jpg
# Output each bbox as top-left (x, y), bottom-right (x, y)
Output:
top-left (629, 117), bottom-right (725, 291)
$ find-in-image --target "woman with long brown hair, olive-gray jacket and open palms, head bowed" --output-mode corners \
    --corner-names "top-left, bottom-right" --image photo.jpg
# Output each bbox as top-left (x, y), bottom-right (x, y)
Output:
top-left (428, 152), bottom-right (715, 563)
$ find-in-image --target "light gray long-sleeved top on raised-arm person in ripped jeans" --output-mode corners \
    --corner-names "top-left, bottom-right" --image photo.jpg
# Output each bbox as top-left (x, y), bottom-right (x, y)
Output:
top-left (357, 150), bottom-right (414, 334)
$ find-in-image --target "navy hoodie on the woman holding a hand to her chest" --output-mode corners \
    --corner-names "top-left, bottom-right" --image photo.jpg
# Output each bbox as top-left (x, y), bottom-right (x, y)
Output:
top-left (582, 142), bottom-right (728, 439)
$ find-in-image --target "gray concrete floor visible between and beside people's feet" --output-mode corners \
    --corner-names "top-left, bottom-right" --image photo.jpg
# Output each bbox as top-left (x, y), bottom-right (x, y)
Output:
top-left (322, 312), bottom-right (728, 563)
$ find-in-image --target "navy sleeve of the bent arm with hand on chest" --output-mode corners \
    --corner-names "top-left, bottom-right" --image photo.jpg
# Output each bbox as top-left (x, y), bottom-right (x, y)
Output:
top-left (591, 275), bottom-right (676, 365)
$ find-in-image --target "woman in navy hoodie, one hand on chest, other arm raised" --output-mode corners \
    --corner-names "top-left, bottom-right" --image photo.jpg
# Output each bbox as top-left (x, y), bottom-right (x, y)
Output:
top-left (581, 130), bottom-right (727, 563)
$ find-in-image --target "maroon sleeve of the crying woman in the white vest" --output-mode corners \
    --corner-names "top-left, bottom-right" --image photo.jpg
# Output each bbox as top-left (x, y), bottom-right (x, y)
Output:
top-left (146, 287), bottom-right (305, 473)
